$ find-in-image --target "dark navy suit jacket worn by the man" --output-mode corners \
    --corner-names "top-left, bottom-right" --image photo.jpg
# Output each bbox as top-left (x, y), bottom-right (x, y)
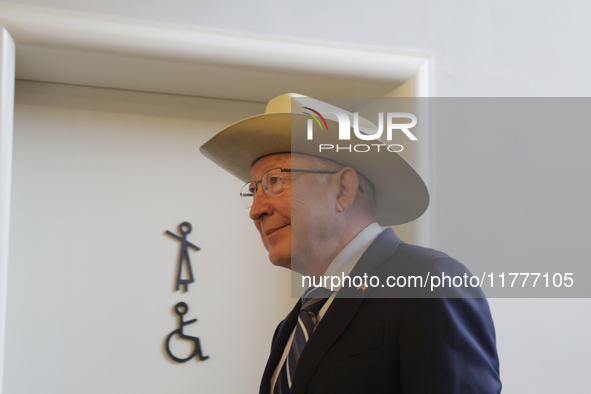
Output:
top-left (260, 229), bottom-right (501, 394)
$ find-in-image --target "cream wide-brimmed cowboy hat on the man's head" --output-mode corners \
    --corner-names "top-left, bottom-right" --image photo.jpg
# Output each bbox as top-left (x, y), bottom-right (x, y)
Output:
top-left (200, 93), bottom-right (429, 226)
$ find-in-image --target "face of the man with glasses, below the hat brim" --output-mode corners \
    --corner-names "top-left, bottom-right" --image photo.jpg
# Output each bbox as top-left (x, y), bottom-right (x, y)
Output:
top-left (250, 153), bottom-right (334, 273)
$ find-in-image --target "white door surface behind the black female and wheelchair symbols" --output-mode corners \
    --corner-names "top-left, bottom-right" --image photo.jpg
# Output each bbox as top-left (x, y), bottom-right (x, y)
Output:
top-left (3, 81), bottom-right (292, 394)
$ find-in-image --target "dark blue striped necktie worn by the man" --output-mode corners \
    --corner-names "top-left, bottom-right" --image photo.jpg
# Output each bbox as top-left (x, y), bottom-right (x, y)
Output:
top-left (273, 287), bottom-right (333, 394)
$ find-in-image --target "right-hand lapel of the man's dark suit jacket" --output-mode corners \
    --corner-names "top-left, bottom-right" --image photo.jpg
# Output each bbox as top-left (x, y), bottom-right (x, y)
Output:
top-left (290, 228), bottom-right (402, 394)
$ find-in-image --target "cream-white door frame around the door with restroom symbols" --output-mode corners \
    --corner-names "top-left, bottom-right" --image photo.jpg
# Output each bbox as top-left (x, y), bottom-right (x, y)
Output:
top-left (0, 5), bottom-right (433, 394)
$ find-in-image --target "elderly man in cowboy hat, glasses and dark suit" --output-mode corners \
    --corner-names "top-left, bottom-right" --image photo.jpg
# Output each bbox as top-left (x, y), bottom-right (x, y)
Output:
top-left (201, 94), bottom-right (501, 394)
